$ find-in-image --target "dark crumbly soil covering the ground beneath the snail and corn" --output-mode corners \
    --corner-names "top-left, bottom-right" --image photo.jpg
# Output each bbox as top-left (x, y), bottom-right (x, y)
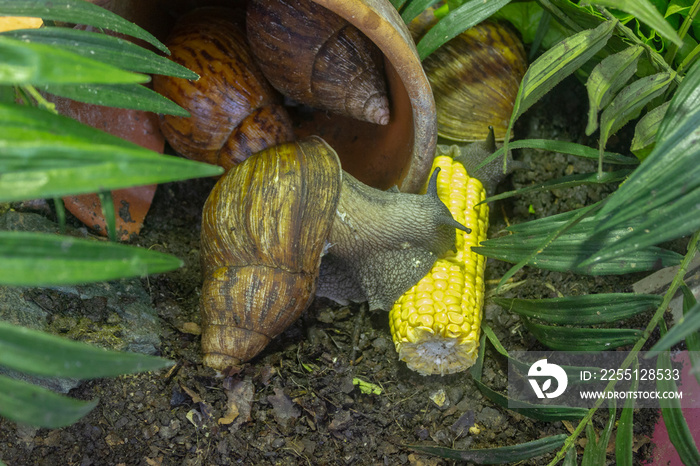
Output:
top-left (0, 79), bottom-right (655, 466)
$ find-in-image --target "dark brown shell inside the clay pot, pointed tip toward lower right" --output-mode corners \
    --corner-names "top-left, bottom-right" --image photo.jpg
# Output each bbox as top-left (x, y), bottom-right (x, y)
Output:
top-left (247, 0), bottom-right (390, 125)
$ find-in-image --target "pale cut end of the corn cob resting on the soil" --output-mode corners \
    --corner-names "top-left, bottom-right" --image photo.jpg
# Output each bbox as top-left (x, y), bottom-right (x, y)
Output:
top-left (395, 329), bottom-right (479, 375)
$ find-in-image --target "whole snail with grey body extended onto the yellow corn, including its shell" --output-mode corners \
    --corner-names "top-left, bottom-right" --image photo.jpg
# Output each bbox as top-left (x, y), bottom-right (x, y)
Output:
top-left (201, 137), bottom-right (464, 369)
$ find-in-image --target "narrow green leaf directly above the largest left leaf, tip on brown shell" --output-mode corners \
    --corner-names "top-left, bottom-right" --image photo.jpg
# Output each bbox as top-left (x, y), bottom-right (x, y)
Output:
top-left (40, 84), bottom-right (190, 117)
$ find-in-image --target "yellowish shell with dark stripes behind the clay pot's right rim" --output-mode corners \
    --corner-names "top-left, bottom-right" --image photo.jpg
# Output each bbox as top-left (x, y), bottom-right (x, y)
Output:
top-left (412, 21), bottom-right (527, 142)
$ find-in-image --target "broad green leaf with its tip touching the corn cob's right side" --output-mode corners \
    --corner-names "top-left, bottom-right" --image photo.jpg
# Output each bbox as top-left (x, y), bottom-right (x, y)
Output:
top-left (472, 215), bottom-right (681, 275)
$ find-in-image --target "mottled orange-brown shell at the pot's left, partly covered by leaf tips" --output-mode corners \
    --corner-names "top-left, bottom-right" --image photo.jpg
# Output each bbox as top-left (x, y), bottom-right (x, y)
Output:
top-left (153, 8), bottom-right (294, 170)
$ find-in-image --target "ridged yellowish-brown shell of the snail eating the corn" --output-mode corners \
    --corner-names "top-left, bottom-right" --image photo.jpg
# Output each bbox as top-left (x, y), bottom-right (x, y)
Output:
top-left (201, 138), bottom-right (341, 369)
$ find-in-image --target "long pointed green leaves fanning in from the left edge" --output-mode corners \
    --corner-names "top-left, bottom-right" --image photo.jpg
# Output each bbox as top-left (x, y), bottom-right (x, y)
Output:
top-left (0, 0), bottom-right (216, 428)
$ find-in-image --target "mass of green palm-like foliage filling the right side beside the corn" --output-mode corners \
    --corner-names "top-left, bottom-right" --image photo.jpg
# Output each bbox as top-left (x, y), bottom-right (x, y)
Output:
top-left (407, 0), bottom-right (700, 465)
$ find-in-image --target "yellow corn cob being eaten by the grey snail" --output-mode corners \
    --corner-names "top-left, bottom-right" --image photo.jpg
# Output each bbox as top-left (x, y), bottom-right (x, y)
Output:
top-left (389, 156), bottom-right (489, 375)
